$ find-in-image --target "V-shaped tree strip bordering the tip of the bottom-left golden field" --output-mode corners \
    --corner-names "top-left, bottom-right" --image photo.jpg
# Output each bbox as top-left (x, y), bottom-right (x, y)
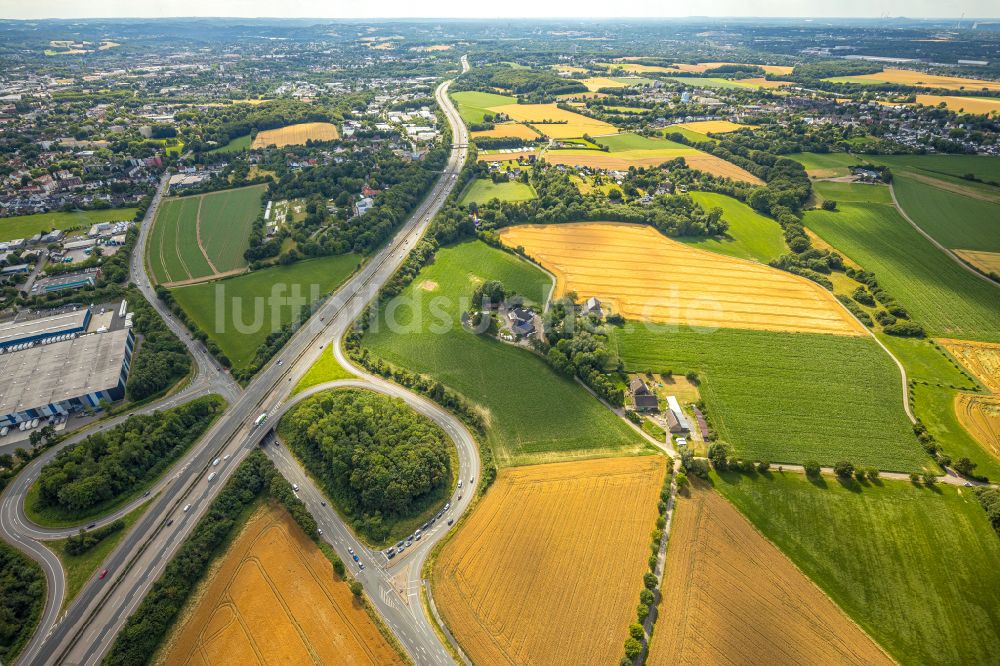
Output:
top-left (104, 451), bottom-right (320, 666)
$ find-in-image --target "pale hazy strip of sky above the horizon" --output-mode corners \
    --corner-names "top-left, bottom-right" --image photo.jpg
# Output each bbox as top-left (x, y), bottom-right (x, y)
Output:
top-left (0, 0), bottom-right (1000, 19)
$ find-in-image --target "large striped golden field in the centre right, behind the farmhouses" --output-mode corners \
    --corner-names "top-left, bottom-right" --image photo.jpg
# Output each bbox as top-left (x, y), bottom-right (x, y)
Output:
top-left (500, 222), bottom-right (866, 335)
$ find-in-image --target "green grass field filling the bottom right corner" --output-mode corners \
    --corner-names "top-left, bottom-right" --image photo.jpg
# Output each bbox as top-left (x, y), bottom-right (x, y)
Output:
top-left (715, 474), bottom-right (1000, 664)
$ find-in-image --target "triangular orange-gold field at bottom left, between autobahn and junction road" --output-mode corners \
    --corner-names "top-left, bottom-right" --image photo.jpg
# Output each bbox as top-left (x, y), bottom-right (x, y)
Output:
top-left (157, 506), bottom-right (403, 666)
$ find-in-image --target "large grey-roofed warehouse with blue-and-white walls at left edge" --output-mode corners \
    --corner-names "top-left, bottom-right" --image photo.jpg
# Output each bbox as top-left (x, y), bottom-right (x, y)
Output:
top-left (0, 304), bottom-right (135, 426)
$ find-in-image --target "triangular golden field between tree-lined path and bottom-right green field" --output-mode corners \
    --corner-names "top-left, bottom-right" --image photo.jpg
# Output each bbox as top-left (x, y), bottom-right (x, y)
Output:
top-left (647, 482), bottom-right (893, 666)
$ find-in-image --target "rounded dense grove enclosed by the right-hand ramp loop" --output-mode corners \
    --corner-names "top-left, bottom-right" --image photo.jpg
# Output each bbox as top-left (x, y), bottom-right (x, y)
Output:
top-left (281, 390), bottom-right (451, 541)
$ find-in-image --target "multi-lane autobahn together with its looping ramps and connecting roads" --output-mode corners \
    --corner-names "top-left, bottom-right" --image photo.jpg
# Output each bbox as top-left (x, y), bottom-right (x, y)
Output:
top-left (0, 57), bottom-right (479, 664)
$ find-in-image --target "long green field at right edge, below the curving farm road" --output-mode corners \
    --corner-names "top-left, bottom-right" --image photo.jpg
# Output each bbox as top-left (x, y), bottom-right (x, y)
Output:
top-left (804, 203), bottom-right (1000, 342)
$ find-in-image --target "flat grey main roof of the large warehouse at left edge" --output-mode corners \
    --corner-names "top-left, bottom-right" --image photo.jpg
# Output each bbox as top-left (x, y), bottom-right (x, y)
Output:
top-left (0, 328), bottom-right (130, 415)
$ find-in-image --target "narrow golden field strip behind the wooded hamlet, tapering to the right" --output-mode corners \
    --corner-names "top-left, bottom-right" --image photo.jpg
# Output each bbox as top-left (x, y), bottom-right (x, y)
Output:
top-left (544, 147), bottom-right (764, 185)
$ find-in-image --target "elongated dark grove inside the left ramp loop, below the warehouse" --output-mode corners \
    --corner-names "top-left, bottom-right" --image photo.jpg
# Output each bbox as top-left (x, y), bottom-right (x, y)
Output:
top-left (37, 396), bottom-right (223, 513)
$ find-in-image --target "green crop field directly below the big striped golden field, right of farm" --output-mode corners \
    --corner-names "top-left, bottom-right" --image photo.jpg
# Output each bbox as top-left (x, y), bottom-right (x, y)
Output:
top-left (614, 325), bottom-right (924, 471)
